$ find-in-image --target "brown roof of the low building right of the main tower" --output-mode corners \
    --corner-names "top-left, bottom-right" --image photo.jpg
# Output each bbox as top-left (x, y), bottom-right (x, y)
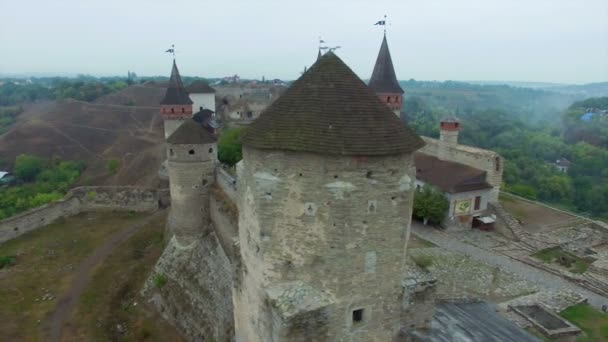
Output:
top-left (414, 152), bottom-right (492, 193)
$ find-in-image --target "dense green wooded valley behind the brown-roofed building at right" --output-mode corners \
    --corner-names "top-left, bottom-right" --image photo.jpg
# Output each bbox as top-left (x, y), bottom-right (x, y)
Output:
top-left (404, 97), bottom-right (608, 217)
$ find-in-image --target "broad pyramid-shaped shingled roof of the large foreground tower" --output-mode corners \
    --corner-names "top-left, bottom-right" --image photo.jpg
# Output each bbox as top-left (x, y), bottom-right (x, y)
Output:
top-left (243, 52), bottom-right (424, 156)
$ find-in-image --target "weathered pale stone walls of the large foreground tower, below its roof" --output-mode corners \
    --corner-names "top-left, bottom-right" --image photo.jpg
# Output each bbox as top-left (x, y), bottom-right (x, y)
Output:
top-left (234, 148), bottom-right (414, 342)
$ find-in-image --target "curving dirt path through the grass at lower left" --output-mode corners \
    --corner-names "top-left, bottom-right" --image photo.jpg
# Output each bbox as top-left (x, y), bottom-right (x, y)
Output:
top-left (44, 210), bottom-right (164, 342)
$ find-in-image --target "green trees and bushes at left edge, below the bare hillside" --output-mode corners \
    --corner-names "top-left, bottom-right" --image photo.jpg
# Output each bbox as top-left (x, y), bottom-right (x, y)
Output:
top-left (0, 155), bottom-right (85, 219)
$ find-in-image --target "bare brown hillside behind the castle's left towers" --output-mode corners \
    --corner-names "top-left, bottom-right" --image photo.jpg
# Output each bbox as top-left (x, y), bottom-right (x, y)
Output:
top-left (0, 96), bottom-right (164, 186)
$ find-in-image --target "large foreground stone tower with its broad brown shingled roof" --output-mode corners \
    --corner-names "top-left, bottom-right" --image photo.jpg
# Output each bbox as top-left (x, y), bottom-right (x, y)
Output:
top-left (233, 50), bottom-right (424, 342)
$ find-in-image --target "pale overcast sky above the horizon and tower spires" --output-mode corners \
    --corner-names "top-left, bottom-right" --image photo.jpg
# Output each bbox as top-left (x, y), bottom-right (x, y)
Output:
top-left (0, 0), bottom-right (608, 83)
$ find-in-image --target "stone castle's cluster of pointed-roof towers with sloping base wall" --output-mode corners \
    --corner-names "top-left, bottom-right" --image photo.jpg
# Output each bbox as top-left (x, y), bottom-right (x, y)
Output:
top-left (143, 36), bottom-right (496, 342)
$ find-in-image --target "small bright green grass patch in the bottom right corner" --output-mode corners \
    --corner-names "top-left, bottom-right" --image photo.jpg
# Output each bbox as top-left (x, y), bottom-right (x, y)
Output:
top-left (560, 304), bottom-right (608, 342)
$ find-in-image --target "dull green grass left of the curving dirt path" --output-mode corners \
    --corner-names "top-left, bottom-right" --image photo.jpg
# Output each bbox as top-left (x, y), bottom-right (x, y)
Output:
top-left (0, 212), bottom-right (141, 341)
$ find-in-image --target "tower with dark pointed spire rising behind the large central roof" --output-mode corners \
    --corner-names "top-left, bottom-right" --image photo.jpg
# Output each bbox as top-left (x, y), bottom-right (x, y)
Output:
top-left (369, 33), bottom-right (404, 117)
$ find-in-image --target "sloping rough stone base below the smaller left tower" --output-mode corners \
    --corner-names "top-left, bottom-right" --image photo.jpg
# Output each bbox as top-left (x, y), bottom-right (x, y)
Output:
top-left (143, 231), bottom-right (234, 341)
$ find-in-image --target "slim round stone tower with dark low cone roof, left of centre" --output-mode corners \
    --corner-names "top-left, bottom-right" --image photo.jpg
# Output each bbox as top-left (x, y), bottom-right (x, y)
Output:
top-left (167, 120), bottom-right (217, 247)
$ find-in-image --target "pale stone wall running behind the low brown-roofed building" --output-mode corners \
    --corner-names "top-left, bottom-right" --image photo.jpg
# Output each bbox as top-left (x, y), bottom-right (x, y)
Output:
top-left (419, 137), bottom-right (504, 202)
